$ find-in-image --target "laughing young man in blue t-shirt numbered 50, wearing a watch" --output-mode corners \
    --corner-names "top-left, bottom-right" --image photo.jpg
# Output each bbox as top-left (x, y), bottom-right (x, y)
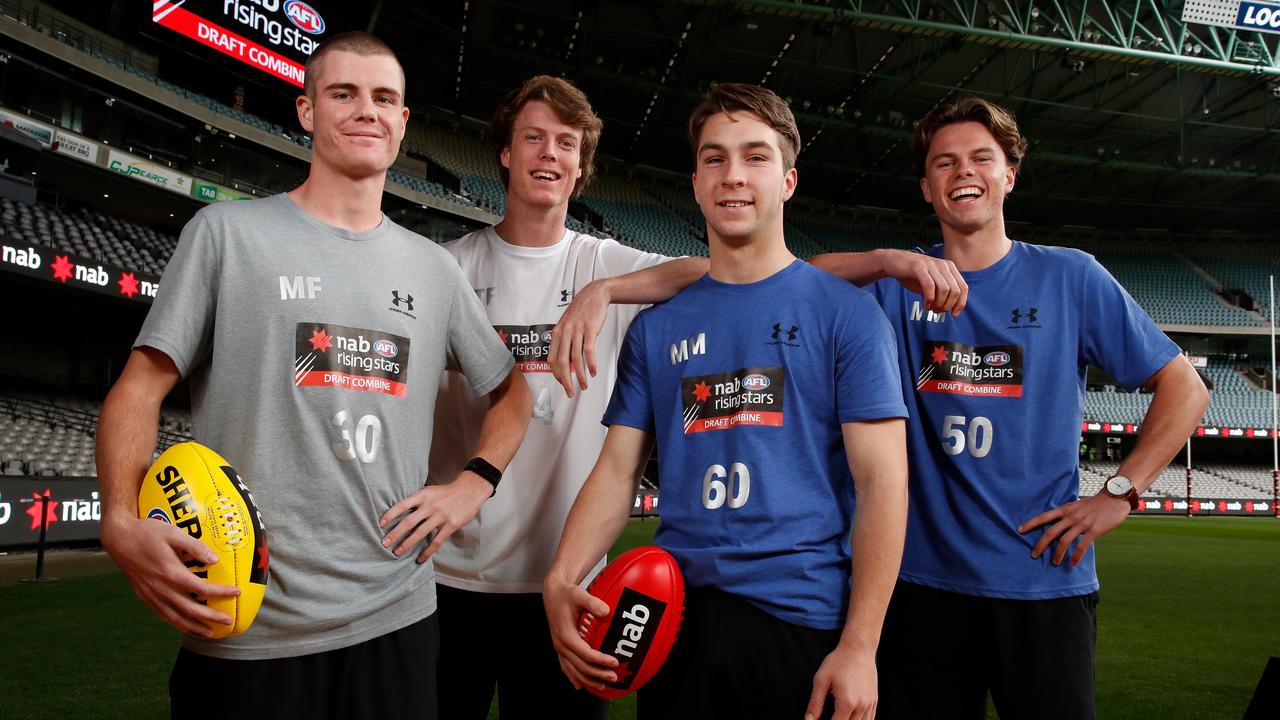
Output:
top-left (814, 97), bottom-right (1208, 720)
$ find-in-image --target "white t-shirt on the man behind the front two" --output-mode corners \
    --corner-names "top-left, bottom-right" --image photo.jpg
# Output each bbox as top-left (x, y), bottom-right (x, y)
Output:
top-left (430, 227), bottom-right (671, 593)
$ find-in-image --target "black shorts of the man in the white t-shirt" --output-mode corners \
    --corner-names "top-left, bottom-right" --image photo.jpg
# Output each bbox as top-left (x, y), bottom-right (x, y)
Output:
top-left (436, 584), bottom-right (609, 720)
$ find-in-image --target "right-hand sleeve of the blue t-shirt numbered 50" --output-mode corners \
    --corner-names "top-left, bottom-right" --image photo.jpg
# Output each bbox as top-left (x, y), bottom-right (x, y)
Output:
top-left (1080, 258), bottom-right (1181, 391)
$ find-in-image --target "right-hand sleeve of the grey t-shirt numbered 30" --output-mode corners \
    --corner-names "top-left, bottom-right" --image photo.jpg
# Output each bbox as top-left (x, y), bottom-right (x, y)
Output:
top-left (440, 258), bottom-right (516, 395)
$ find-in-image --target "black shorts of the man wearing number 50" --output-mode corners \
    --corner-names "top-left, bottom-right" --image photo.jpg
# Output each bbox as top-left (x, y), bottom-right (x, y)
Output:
top-left (877, 580), bottom-right (1098, 720)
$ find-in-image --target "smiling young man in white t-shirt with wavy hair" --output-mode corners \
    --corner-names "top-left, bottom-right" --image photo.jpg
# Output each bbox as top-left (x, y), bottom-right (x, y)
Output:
top-left (431, 76), bottom-right (707, 720)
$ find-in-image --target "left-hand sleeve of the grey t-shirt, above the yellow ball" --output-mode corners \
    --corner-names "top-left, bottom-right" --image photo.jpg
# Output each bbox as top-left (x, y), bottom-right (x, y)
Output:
top-left (133, 213), bottom-right (221, 378)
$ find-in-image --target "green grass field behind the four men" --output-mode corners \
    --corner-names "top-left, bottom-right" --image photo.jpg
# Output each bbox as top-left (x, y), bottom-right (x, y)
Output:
top-left (0, 518), bottom-right (1280, 720)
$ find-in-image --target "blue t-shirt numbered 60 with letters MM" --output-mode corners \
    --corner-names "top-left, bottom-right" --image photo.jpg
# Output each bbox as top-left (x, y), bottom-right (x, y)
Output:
top-left (604, 260), bottom-right (906, 629)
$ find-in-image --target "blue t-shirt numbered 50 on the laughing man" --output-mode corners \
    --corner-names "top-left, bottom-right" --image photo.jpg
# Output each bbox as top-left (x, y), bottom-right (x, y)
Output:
top-left (873, 242), bottom-right (1179, 600)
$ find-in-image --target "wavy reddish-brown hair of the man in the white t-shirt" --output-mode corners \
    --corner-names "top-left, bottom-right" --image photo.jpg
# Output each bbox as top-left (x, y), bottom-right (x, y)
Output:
top-left (489, 76), bottom-right (604, 196)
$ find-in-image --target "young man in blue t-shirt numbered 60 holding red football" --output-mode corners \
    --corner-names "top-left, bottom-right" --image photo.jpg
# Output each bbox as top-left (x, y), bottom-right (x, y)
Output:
top-left (544, 83), bottom-right (906, 720)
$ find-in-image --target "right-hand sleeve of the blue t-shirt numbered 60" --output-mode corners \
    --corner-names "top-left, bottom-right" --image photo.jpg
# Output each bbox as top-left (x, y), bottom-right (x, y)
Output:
top-left (836, 291), bottom-right (906, 423)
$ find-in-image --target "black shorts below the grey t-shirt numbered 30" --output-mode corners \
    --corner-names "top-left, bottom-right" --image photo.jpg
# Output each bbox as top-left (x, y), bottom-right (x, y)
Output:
top-left (169, 615), bottom-right (440, 720)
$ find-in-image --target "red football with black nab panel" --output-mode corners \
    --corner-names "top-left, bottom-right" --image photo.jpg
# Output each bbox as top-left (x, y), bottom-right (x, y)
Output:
top-left (577, 546), bottom-right (685, 700)
